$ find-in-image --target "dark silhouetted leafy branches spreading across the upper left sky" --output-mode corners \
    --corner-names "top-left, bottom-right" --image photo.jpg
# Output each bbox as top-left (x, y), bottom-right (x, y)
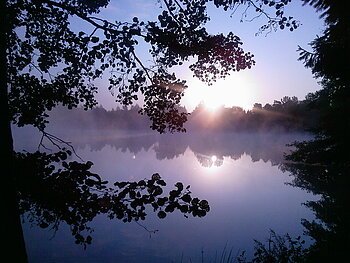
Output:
top-left (0, 0), bottom-right (304, 262)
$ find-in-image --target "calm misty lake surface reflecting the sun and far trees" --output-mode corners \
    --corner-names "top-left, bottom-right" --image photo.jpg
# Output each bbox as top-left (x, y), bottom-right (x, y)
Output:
top-left (15, 129), bottom-right (317, 263)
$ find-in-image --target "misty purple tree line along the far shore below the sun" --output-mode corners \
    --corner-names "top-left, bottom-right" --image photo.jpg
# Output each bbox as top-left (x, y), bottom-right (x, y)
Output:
top-left (50, 96), bottom-right (320, 132)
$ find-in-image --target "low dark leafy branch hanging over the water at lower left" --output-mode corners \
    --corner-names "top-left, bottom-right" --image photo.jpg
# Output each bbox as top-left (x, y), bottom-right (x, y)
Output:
top-left (15, 152), bottom-right (210, 247)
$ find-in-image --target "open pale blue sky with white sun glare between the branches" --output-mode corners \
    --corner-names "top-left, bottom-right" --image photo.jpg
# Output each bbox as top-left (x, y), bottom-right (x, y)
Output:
top-left (93, 0), bottom-right (323, 111)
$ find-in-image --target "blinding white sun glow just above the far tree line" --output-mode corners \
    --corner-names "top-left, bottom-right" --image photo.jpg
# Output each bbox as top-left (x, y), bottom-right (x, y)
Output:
top-left (182, 73), bottom-right (256, 111)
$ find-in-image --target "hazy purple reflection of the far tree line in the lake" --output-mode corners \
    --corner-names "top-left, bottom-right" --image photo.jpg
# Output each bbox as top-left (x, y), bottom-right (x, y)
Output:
top-left (21, 130), bottom-right (310, 167)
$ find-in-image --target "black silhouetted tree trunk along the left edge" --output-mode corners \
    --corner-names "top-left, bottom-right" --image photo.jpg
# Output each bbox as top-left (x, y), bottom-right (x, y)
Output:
top-left (0, 1), bottom-right (28, 263)
